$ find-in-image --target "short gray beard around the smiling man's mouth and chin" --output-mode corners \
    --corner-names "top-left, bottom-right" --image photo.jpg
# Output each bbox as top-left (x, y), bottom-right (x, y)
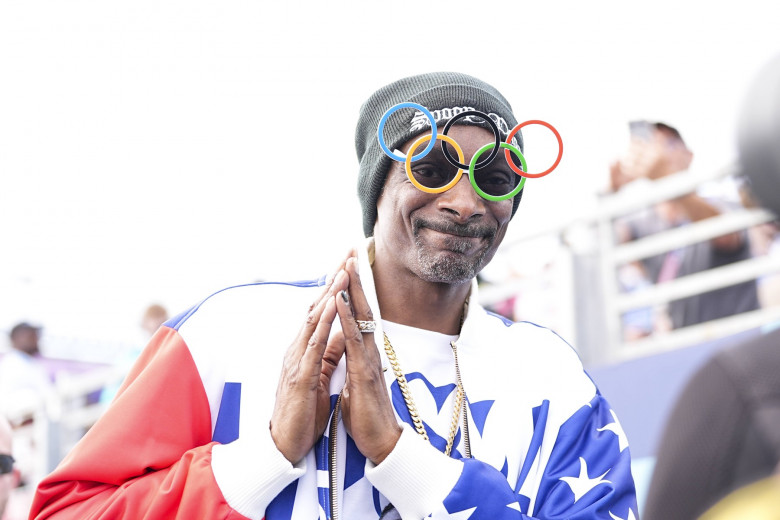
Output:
top-left (414, 221), bottom-right (495, 284)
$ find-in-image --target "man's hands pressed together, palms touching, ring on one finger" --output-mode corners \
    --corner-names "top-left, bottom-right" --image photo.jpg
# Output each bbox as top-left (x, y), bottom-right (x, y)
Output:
top-left (271, 251), bottom-right (401, 464)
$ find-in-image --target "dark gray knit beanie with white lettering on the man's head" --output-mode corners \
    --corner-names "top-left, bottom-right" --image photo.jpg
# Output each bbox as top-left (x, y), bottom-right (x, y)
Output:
top-left (355, 72), bottom-right (523, 237)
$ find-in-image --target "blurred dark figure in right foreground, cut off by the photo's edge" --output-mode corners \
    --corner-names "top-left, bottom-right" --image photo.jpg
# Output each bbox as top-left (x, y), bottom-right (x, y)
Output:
top-left (642, 52), bottom-right (780, 520)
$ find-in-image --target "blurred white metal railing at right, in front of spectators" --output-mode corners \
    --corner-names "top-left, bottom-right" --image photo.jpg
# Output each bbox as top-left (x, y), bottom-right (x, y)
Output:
top-left (480, 166), bottom-right (780, 363)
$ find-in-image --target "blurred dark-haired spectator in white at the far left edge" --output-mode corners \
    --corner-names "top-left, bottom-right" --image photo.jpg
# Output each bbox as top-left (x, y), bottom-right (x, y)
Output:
top-left (0, 322), bottom-right (52, 420)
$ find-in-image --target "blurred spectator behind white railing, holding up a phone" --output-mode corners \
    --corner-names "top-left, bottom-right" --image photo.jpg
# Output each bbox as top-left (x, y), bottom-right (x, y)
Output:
top-left (610, 121), bottom-right (759, 339)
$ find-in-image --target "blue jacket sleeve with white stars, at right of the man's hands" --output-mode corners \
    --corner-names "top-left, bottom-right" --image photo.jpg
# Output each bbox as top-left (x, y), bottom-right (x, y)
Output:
top-left (431, 394), bottom-right (637, 520)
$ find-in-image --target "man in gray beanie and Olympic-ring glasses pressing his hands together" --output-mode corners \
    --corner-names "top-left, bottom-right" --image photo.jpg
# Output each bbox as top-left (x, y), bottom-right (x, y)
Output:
top-left (32, 73), bottom-right (636, 520)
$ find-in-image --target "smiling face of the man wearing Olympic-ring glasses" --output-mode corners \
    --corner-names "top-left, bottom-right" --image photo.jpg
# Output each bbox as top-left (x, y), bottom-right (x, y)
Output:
top-left (374, 125), bottom-right (515, 284)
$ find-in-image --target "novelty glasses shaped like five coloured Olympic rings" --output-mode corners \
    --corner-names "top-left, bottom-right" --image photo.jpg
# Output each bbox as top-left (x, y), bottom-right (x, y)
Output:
top-left (377, 102), bottom-right (563, 201)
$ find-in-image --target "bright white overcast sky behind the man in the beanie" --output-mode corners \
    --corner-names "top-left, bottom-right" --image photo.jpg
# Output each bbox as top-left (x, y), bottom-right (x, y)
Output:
top-left (0, 0), bottom-right (780, 354)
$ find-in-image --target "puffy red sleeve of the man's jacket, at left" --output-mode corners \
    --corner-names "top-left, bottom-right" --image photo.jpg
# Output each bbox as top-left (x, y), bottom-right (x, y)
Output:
top-left (30, 327), bottom-right (246, 520)
